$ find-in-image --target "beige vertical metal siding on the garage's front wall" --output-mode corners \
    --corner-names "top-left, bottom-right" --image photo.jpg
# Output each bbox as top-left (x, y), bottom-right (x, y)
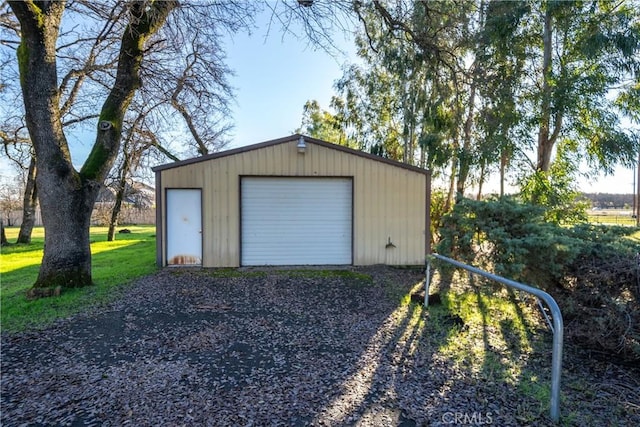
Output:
top-left (159, 141), bottom-right (427, 267)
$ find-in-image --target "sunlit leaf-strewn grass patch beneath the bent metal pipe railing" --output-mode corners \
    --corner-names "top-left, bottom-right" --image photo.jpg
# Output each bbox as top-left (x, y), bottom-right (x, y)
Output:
top-left (422, 274), bottom-right (552, 422)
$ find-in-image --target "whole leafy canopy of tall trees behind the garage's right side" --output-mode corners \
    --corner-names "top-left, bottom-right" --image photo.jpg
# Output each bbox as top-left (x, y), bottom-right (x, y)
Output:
top-left (302, 0), bottom-right (640, 202)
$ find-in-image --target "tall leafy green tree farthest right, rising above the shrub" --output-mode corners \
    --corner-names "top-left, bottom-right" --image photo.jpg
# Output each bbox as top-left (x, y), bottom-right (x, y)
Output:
top-left (526, 1), bottom-right (640, 173)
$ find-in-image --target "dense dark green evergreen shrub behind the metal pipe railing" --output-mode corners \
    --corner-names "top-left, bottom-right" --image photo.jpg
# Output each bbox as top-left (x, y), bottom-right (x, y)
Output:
top-left (436, 197), bottom-right (640, 363)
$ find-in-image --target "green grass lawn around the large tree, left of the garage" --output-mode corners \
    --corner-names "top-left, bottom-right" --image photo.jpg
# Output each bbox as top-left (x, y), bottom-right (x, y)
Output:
top-left (0, 226), bottom-right (156, 331)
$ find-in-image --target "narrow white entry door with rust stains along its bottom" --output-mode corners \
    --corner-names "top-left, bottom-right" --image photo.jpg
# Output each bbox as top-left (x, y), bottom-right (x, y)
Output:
top-left (165, 188), bottom-right (202, 265)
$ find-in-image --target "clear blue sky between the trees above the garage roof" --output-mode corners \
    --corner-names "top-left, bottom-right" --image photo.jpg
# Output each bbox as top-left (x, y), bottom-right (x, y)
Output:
top-left (226, 15), bottom-right (353, 148)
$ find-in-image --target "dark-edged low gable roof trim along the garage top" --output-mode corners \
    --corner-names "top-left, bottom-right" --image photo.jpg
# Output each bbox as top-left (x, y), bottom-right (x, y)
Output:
top-left (152, 133), bottom-right (429, 174)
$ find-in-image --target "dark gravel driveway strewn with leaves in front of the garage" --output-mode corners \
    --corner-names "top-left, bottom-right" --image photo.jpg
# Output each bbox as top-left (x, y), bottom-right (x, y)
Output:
top-left (1, 267), bottom-right (640, 426)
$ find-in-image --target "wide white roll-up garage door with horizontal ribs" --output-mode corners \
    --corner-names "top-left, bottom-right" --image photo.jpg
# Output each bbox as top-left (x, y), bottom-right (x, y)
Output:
top-left (241, 177), bottom-right (352, 265)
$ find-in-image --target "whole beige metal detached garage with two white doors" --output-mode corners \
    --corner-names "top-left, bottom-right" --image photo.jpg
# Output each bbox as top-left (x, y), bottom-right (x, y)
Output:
top-left (154, 135), bottom-right (429, 267)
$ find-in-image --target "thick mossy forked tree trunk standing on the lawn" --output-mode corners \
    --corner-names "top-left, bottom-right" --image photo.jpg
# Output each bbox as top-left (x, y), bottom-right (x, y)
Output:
top-left (9, 1), bottom-right (177, 288)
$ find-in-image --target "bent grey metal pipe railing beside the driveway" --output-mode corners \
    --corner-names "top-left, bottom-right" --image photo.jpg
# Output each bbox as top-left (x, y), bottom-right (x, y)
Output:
top-left (424, 253), bottom-right (563, 423)
